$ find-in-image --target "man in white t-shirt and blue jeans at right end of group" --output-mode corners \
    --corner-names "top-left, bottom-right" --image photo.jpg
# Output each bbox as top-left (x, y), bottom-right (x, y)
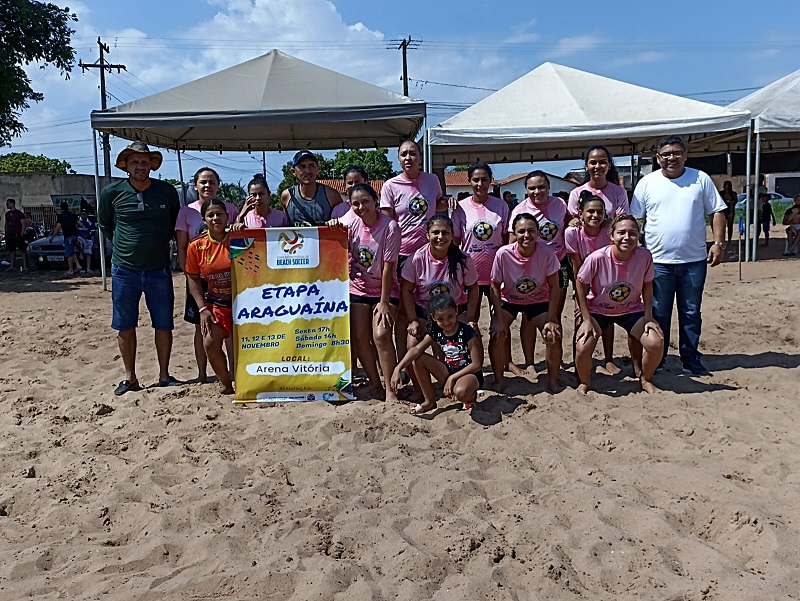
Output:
top-left (631, 136), bottom-right (726, 376)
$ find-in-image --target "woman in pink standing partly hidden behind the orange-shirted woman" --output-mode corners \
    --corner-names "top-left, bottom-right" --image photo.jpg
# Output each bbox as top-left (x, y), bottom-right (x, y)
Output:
top-left (175, 167), bottom-right (239, 384)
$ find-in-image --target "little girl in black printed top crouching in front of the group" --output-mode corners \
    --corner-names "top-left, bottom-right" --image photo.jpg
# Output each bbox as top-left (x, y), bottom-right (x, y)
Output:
top-left (390, 294), bottom-right (483, 415)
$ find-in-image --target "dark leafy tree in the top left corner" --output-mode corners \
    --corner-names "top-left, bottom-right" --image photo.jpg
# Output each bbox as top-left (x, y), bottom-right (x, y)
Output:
top-left (0, 0), bottom-right (78, 145)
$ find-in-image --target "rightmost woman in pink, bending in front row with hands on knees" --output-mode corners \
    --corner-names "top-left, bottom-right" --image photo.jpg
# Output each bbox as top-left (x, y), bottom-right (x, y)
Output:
top-left (575, 215), bottom-right (664, 394)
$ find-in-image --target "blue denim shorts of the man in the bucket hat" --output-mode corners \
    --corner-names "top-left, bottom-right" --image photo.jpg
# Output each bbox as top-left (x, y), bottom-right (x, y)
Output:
top-left (111, 264), bottom-right (175, 331)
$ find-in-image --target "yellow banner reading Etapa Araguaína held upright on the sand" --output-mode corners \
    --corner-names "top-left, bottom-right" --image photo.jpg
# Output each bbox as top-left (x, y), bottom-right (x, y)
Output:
top-left (230, 227), bottom-right (354, 403)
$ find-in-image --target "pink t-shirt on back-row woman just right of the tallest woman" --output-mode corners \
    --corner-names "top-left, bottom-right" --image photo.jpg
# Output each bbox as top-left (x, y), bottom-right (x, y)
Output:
top-left (452, 196), bottom-right (509, 285)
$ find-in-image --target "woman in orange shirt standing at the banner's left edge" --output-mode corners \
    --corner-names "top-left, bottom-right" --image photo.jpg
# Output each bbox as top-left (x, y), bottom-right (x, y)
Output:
top-left (185, 199), bottom-right (233, 394)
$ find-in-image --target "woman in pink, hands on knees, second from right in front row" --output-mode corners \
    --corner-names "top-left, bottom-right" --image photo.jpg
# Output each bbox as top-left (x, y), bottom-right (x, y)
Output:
top-left (489, 213), bottom-right (563, 392)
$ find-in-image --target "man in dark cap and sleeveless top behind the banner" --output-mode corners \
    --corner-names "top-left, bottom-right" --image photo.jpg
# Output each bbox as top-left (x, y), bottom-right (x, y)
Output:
top-left (281, 150), bottom-right (342, 227)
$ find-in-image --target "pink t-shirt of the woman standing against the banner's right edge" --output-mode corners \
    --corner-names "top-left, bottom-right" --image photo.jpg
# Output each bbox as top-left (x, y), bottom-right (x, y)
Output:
top-left (348, 213), bottom-right (400, 298)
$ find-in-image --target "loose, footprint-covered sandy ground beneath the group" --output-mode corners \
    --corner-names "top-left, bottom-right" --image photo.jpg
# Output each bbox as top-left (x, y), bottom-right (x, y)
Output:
top-left (0, 245), bottom-right (800, 601)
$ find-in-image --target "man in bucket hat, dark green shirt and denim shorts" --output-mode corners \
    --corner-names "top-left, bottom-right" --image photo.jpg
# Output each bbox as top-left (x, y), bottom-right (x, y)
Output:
top-left (97, 142), bottom-right (180, 396)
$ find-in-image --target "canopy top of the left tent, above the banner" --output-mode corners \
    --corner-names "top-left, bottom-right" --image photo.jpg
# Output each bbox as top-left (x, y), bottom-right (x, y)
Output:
top-left (91, 50), bottom-right (425, 151)
